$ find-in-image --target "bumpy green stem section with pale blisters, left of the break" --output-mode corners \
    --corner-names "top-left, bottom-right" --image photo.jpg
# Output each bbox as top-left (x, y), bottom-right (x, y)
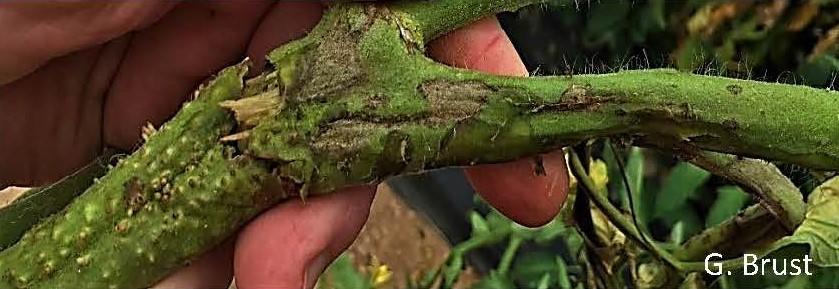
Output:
top-left (0, 65), bottom-right (286, 288)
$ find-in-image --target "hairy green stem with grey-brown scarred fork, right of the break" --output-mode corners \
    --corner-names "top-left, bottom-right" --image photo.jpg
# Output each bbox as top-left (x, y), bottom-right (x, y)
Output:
top-left (244, 1), bottom-right (839, 194)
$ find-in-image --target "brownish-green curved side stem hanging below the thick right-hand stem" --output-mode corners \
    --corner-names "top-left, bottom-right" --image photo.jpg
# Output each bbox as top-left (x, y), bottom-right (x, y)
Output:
top-left (685, 151), bottom-right (807, 232)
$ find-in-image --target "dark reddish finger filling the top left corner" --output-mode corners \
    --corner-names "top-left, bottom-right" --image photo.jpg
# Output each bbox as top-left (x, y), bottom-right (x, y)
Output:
top-left (0, 0), bottom-right (173, 85)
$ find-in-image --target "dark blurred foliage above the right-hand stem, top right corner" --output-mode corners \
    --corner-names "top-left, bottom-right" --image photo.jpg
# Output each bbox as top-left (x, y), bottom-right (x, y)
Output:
top-left (508, 0), bottom-right (839, 87)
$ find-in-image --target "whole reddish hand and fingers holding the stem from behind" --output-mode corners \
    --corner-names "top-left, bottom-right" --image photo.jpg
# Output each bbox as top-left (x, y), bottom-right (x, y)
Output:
top-left (0, 0), bottom-right (568, 288)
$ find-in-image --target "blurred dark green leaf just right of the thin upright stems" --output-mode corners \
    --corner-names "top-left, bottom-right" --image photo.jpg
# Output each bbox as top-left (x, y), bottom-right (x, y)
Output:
top-left (653, 162), bottom-right (711, 218)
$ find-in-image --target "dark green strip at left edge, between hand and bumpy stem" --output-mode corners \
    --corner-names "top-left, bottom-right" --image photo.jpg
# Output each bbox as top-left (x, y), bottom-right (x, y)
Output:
top-left (0, 152), bottom-right (113, 251)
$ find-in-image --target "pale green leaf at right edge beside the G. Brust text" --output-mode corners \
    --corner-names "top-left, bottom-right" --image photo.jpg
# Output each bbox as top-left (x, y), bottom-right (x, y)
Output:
top-left (772, 177), bottom-right (839, 267)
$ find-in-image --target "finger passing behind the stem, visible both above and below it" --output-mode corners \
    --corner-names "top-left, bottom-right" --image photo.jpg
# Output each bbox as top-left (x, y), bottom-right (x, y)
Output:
top-left (429, 17), bottom-right (568, 226)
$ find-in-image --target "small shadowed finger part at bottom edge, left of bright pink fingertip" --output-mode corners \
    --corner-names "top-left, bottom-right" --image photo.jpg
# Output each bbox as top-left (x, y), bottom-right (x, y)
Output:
top-left (152, 237), bottom-right (236, 289)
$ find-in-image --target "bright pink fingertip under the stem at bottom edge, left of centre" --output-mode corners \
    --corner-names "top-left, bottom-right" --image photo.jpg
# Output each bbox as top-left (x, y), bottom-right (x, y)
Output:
top-left (234, 186), bottom-right (375, 289)
